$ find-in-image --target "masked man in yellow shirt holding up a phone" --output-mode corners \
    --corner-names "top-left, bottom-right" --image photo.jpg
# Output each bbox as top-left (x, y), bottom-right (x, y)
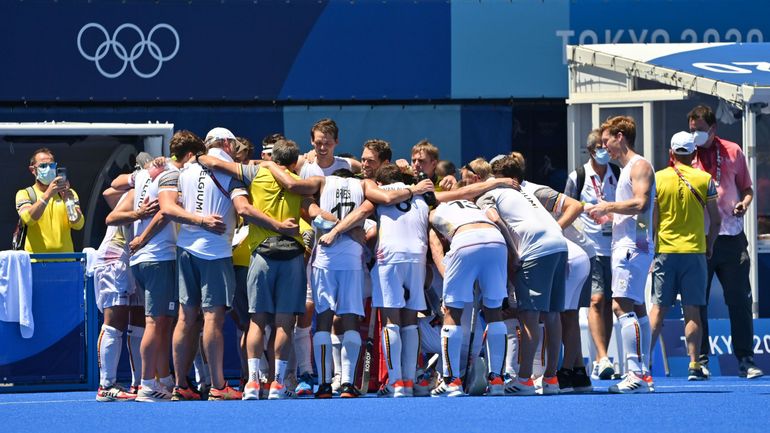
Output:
top-left (16, 148), bottom-right (85, 253)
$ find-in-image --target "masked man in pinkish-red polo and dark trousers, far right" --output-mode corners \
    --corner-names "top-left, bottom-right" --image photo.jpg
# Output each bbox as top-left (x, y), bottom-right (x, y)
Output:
top-left (687, 105), bottom-right (764, 379)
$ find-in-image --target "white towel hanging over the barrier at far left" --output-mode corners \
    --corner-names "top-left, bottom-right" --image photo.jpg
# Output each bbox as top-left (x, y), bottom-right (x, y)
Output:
top-left (0, 251), bottom-right (35, 338)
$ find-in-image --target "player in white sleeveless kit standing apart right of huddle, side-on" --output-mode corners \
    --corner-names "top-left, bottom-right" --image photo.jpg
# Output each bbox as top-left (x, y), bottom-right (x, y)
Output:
top-left (586, 116), bottom-right (655, 394)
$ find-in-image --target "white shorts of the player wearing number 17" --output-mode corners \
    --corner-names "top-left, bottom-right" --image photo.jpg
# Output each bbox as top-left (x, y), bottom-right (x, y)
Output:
top-left (311, 267), bottom-right (364, 316)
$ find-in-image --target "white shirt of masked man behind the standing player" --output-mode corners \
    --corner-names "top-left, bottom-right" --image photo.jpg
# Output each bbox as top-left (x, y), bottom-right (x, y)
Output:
top-left (564, 161), bottom-right (618, 256)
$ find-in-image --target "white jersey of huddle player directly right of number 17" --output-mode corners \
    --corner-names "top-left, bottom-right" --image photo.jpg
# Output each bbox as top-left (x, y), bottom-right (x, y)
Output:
top-left (376, 182), bottom-right (430, 264)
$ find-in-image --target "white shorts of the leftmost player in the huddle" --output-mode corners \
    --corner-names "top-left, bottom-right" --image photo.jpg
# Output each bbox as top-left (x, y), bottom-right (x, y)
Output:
top-left (94, 260), bottom-right (144, 312)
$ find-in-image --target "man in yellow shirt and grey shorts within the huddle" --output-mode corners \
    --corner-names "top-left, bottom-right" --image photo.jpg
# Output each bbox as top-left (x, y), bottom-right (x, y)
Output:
top-left (199, 140), bottom-right (306, 400)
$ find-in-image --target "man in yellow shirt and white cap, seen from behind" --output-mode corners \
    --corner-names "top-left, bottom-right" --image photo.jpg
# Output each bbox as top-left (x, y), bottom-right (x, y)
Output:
top-left (650, 131), bottom-right (721, 380)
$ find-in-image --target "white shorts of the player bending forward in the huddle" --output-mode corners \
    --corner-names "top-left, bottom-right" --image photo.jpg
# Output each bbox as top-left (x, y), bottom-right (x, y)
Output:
top-left (443, 228), bottom-right (508, 308)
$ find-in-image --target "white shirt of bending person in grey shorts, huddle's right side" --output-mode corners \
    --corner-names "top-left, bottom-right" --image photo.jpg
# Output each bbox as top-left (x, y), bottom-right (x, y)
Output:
top-left (477, 185), bottom-right (567, 260)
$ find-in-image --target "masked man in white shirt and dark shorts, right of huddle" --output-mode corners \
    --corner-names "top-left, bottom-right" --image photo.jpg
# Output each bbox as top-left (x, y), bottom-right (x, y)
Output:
top-left (564, 129), bottom-right (620, 380)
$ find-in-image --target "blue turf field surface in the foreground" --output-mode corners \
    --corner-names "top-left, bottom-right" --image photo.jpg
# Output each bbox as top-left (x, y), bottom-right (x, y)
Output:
top-left (0, 377), bottom-right (770, 433)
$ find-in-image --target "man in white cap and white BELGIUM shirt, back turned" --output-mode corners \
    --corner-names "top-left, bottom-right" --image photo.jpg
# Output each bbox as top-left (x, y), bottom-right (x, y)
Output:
top-left (159, 128), bottom-right (241, 400)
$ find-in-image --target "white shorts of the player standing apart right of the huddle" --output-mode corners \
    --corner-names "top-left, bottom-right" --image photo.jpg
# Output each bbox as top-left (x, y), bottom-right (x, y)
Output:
top-left (612, 248), bottom-right (655, 304)
